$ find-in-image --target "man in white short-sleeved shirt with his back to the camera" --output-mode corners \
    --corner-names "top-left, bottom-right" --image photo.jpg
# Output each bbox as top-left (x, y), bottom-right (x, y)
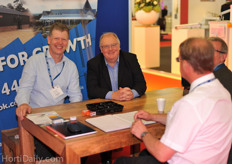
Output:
top-left (115, 38), bottom-right (232, 164)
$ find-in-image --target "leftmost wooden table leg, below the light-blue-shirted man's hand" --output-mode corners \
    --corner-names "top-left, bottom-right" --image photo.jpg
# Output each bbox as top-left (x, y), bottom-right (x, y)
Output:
top-left (18, 120), bottom-right (35, 163)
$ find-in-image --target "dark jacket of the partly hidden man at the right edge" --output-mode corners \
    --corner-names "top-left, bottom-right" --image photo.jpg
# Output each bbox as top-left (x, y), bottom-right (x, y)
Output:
top-left (213, 66), bottom-right (232, 98)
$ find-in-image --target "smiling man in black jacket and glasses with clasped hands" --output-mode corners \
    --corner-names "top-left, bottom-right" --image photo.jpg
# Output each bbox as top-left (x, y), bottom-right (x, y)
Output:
top-left (87, 32), bottom-right (147, 163)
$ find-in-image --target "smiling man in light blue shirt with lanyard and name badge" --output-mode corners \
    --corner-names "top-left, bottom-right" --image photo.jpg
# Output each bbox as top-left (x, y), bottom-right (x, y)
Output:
top-left (15, 23), bottom-right (82, 158)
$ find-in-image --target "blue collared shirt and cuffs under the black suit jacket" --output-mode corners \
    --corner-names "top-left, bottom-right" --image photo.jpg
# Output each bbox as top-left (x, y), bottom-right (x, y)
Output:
top-left (105, 57), bottom-right (139, 99)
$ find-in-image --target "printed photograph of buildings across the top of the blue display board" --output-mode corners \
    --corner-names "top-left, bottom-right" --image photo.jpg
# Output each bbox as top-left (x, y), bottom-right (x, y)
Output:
top-left (0, 0), bottom-right (97, 49)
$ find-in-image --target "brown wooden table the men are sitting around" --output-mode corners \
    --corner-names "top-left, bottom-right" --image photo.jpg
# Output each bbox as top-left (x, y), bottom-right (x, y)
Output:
top-left (19, 88), bottom-right (183, 164)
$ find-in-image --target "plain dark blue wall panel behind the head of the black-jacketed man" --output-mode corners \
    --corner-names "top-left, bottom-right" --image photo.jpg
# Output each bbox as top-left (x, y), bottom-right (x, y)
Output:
top-left (95, 0), bottom-right (129, 55)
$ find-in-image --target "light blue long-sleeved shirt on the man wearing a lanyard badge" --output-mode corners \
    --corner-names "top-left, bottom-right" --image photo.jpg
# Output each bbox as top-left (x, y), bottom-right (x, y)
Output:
top-left (15, 51), bottom-right (82, 108)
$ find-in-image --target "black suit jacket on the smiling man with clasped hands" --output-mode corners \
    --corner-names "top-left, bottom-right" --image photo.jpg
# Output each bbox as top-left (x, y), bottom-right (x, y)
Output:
top-left (87, 51), bottom-right (147, 99)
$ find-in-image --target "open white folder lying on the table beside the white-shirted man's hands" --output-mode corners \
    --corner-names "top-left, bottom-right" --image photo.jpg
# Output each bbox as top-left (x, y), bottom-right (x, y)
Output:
top-left (86, 111), bottom-right (155, 132)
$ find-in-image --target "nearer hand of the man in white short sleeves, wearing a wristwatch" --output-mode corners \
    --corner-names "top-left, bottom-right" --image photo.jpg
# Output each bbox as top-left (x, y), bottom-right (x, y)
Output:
top-left (131, 119), bottom-right (148, 139)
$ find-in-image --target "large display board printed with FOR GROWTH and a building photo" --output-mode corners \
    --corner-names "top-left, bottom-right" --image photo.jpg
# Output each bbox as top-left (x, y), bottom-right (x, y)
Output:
top-left (0, 0), bottom-right (97, 163)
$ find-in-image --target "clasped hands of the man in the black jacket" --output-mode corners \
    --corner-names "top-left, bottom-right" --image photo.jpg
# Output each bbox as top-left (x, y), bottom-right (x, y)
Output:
top-left (112, 87), bottom-right (134, 101)
